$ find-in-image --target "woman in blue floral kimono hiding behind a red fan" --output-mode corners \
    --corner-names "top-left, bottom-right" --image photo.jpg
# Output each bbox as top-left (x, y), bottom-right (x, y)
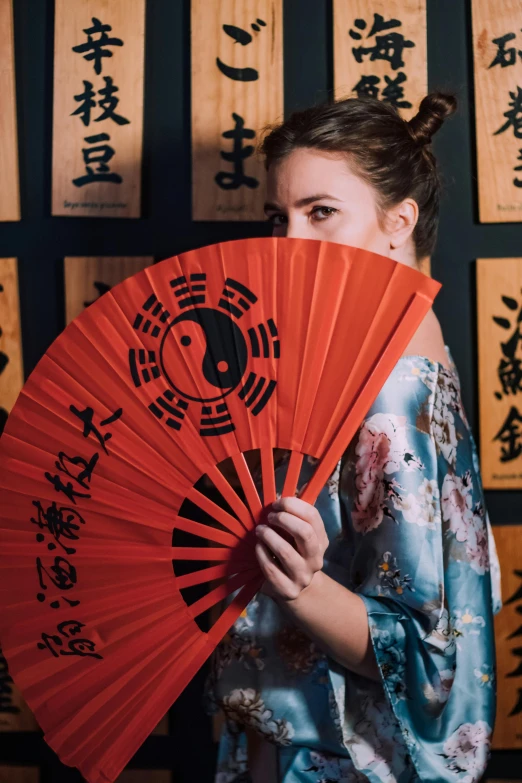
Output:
top-left (203, 93), bottom-right (501, 783)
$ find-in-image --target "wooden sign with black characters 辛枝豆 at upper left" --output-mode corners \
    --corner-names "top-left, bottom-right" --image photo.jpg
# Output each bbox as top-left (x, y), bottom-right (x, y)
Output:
top-left (52, 0), bottom-right (145, 217)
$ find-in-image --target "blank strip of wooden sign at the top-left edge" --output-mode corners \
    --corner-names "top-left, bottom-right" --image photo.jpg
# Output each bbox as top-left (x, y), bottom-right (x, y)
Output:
top-left (0, 0), bottom-right (20, 220)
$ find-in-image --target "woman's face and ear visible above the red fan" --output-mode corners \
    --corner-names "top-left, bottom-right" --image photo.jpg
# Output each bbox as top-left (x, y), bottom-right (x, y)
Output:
top-left (265, 149), bottom-right (417, 263)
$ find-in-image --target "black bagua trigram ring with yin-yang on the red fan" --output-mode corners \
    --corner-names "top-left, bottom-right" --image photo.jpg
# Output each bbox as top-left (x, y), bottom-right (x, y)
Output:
top-left (129, 273), bottom-right (280, 436)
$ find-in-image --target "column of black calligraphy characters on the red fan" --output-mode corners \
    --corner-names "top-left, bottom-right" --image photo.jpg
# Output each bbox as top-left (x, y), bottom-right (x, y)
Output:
top-left (34, 404), bottom-right (122, 658)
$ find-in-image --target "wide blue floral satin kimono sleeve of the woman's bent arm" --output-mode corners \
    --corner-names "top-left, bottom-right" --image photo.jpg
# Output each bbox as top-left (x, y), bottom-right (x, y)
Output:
top-left (340, 357), bottom-right (500, 783)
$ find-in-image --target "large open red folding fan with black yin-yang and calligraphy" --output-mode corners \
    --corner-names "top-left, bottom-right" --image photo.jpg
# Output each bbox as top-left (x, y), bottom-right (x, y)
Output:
top-left (0, 238), bottom-right (440, 783)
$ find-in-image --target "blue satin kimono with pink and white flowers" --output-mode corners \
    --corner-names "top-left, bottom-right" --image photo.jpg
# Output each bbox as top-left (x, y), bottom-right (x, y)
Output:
top-left (207, 351), bottom-right (501, 783)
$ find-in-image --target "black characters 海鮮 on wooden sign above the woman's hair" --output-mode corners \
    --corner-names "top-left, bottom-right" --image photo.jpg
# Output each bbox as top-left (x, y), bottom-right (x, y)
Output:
top-left (348, 13), bottom-right (415, 109)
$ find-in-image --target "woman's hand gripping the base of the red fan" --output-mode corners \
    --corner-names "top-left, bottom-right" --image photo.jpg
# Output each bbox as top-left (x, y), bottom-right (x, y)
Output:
top-left (256, 497), bottom-right (328, 601)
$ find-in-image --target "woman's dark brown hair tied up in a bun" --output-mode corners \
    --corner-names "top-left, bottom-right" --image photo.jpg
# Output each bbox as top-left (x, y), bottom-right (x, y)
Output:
top-left (260, 92), bottom-right (457, 260)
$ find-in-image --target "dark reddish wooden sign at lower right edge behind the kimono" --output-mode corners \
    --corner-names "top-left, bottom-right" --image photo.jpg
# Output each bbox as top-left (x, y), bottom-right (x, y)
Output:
top-left (492, 525), bottom-right (522, 749)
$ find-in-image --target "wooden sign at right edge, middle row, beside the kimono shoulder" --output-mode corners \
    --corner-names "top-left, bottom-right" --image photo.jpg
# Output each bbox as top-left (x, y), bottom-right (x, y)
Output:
top-left (477, 258), bottom-right (522, 489)
